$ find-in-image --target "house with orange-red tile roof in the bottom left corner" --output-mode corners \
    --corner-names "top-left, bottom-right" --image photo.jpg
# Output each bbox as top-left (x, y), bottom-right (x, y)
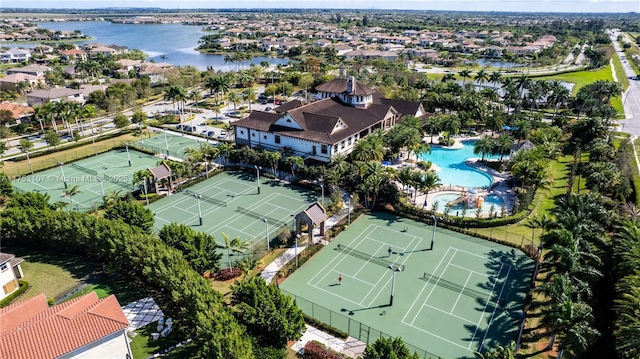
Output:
top-left (0, 292), bottom-right (132, 359)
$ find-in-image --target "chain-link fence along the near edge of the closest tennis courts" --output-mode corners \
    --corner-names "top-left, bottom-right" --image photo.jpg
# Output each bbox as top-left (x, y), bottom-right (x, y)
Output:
top-left (280, 289), bottom-right (439, 359)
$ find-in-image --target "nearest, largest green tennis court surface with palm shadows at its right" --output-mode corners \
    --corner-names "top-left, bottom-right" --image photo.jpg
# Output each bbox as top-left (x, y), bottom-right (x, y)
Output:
top-left (280, 214), bottom-right (535, 358)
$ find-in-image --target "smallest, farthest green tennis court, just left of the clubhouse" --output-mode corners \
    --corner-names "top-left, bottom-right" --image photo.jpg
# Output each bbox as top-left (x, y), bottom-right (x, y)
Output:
top-left (131, 131), bottom-right (207, 158)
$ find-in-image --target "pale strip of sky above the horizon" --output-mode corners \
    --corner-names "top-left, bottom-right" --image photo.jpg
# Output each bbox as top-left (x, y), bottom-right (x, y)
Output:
top-left (0, 0), bottom-right (640, 13)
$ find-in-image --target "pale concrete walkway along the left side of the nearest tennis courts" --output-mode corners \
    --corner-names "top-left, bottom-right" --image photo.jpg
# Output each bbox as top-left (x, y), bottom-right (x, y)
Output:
top-left (260, 190), bottom-right (367, 358)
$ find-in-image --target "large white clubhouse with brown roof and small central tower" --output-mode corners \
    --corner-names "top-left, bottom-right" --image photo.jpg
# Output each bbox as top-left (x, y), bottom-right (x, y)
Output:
top-left (231, 76), bottom-right (425, 162)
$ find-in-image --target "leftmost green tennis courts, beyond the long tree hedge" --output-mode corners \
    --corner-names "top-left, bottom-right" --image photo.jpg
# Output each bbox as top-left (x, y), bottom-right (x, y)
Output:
top-left (11, 149), bottom-right (158, 212)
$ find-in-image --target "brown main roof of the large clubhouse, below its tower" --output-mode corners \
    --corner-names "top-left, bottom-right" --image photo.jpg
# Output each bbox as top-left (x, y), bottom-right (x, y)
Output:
top-left (232, 98), bottom-right (392, 144)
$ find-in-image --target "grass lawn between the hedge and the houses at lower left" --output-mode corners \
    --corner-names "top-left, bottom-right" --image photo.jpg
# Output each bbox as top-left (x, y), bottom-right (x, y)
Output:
top-left (3, 247), bottom-right (99, 301)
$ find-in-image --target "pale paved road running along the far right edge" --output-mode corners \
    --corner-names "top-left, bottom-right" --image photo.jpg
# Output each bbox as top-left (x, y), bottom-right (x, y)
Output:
top-left (609, 31), bottom-right (640, 136)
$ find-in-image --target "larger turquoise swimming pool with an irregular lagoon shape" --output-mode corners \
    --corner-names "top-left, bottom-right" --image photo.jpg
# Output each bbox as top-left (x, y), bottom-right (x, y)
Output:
top-left (420, 141), bottom-right (498, 187)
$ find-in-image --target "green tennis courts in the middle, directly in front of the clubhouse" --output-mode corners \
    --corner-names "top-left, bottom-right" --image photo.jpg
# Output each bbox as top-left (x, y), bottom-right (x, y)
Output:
top-left (147, 171), bottom-right (326, 266)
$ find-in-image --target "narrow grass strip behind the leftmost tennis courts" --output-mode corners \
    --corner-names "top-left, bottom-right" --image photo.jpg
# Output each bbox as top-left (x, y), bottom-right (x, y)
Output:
top-left (2, 133), bottom-right (139, 177)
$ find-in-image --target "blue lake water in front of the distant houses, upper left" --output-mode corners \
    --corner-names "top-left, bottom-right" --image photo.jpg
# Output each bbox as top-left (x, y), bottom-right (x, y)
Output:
top-left (32, 21), bottom-right (289, 71)
